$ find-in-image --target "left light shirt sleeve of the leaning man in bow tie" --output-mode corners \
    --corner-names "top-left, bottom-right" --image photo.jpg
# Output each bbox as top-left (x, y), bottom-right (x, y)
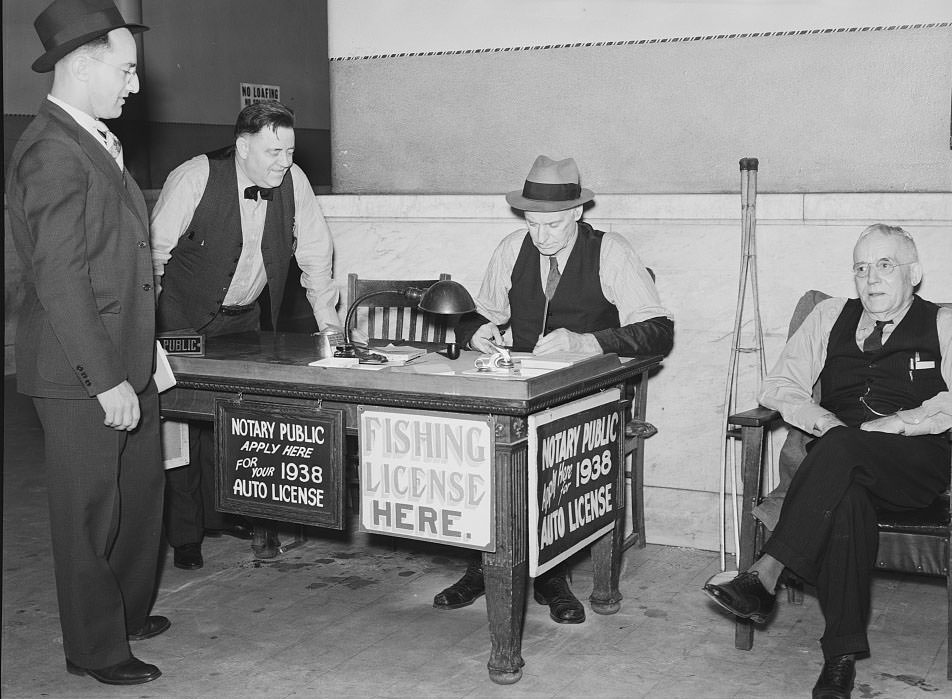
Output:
top-left (151, 155), bottom-right (208, 277)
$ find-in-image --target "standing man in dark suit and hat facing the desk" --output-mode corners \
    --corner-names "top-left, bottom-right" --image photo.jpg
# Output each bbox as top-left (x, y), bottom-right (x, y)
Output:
top-left (7, 0), bottom-right (170, 685)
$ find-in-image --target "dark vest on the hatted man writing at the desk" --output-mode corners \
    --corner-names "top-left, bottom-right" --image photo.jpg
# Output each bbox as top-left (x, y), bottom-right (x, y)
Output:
top-left (509, 221), bottom-right (619, 352)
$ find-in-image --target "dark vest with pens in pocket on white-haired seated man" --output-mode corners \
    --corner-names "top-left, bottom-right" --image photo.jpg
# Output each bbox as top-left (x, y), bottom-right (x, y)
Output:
top-left (820, 296), bottom-right (947, 427)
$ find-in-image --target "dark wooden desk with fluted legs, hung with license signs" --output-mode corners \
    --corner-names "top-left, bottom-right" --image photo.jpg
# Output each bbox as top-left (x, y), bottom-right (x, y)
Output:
top-left (161, 333), bottom-right (661, 684)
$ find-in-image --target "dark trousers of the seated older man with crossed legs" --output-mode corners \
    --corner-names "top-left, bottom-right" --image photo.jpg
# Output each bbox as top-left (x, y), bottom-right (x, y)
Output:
top-left (764, 427), bottom-right (949, 659)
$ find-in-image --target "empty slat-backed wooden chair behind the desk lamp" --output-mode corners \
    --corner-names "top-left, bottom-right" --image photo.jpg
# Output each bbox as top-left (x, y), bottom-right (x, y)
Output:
top-left (347, 274), bottom-right (450, 342)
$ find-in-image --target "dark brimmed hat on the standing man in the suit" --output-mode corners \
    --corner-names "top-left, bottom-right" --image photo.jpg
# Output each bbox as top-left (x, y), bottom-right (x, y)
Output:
top-left (33, 0), bottom-right (148, 73)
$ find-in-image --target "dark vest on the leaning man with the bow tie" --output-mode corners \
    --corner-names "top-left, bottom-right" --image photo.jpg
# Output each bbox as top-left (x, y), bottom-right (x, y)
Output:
top-left (157, 148), bottom-right (296, 331)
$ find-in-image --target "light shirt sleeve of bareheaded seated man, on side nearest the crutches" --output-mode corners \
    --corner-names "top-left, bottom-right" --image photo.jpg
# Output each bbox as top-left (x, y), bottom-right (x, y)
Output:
top-left (760, 298), bottom-right (846, 435)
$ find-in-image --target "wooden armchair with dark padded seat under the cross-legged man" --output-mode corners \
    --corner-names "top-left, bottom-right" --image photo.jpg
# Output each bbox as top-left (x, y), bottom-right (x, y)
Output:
top-left (728, 292), bottom-right (952, 680)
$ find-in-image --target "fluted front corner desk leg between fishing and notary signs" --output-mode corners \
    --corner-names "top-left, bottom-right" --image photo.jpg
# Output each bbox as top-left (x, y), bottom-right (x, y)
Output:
top-left (483, 416), bottom-right (529, 684)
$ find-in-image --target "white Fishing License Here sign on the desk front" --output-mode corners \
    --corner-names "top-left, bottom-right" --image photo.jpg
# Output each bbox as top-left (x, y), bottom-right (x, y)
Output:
top-left (358, 406), bottom-right (496, 551)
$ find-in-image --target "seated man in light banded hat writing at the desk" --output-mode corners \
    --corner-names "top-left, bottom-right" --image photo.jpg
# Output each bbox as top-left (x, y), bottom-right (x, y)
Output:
top-left (433, 155), bottom-right (674, 624)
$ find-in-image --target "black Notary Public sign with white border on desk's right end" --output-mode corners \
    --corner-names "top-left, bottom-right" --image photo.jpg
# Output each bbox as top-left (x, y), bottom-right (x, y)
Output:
top-left (528, 388), bottom-right (624, 577)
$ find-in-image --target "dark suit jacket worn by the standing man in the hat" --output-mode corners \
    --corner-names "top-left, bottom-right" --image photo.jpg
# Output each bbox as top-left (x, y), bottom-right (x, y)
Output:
top-left (7, 100), bottom-right (155, 398)
